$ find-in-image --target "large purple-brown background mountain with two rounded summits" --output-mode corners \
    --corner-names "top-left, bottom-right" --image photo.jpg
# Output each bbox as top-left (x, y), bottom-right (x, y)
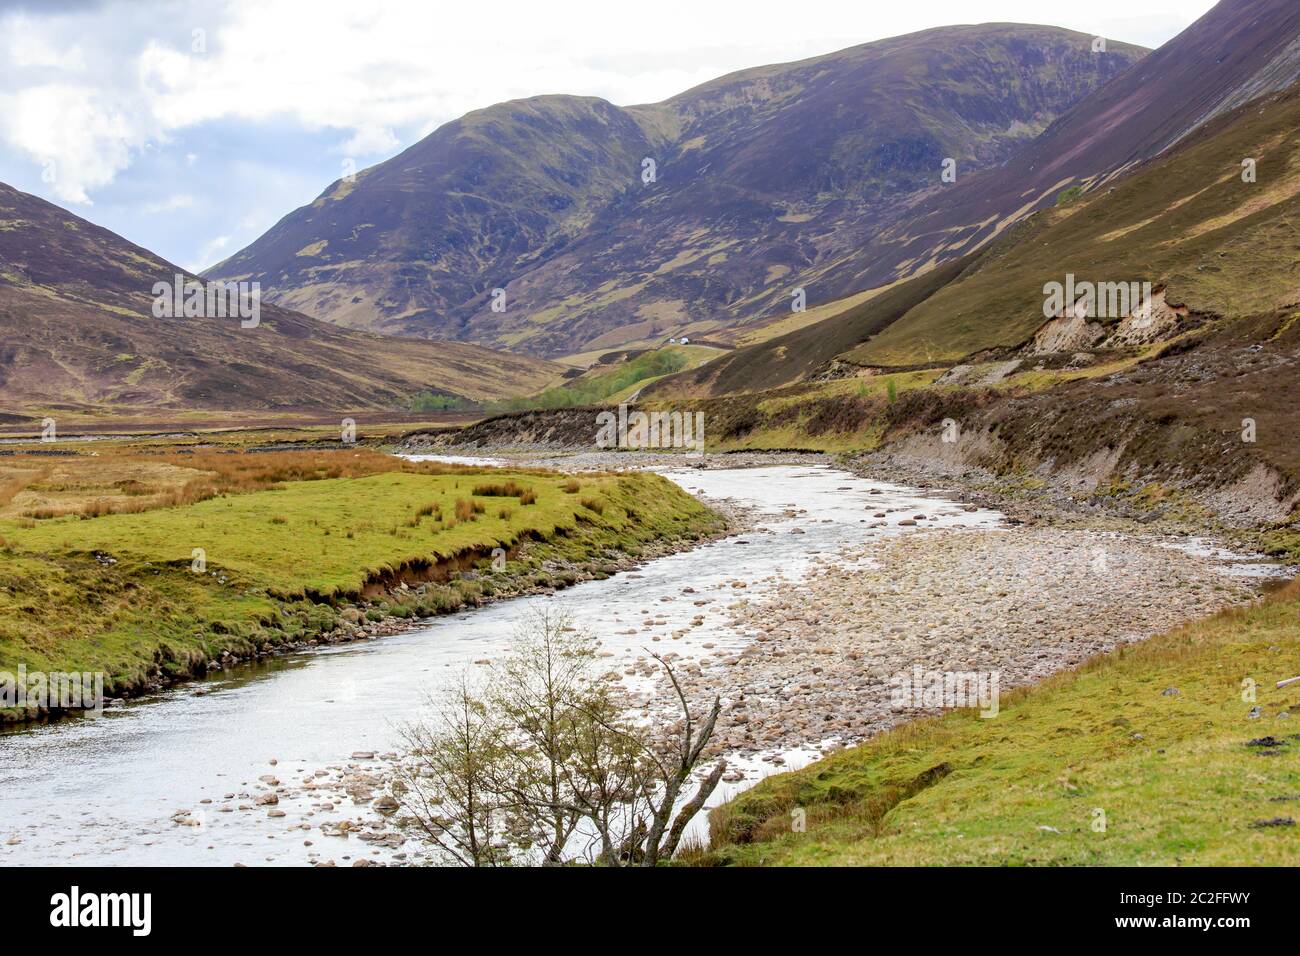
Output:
top-left (209, 23), bottom-right (1145, 355)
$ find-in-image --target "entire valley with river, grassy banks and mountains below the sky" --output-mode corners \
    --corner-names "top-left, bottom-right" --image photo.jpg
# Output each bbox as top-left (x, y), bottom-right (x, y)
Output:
top-left (0, 0), bottom-right (1300, 884)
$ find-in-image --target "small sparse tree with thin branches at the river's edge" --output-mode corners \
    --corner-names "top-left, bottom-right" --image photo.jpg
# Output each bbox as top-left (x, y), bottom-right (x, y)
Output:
top-left (390, 613), bottom-right (725, 866)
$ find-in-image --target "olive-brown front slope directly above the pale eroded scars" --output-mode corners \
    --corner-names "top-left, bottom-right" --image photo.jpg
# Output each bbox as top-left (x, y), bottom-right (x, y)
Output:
top-left (849, 87), bottom-right (1300, 365)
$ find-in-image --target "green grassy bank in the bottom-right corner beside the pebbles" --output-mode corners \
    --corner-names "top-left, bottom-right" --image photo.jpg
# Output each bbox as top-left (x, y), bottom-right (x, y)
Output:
top-left (690, 580), bottom-right (1300, 866)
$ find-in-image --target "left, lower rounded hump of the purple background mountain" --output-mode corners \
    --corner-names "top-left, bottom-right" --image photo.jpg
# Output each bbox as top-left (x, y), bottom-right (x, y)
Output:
top-left (209, 96), bottom-right (654, 338)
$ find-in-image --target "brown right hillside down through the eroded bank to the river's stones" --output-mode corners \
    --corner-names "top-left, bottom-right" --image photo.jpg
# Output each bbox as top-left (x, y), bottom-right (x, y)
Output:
top-left (616, 85), bottom-right (1279, 538)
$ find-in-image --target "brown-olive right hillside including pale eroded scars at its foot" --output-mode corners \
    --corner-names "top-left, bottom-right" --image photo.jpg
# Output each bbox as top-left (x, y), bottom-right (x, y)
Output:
top-left (655, 75), bottom-right (1300, 399)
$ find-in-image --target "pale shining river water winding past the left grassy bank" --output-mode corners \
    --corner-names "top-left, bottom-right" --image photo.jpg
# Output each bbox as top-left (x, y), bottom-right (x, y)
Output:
top-left (0, 466), bottom-right (1001, 866)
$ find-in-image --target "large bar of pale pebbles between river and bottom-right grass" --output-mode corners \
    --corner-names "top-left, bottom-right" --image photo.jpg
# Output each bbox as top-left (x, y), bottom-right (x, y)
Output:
top-left (693, 528), bottom-right (1258, 762)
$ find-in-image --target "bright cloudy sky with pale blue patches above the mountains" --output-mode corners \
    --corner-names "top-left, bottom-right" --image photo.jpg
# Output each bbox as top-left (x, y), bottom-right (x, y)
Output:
top-left (0, 0), bottom-right (1214, 271)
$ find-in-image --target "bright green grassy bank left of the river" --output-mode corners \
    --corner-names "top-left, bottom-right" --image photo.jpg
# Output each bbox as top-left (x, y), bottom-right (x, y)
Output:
top-left (0, 453), bottom-right (723, 721)
